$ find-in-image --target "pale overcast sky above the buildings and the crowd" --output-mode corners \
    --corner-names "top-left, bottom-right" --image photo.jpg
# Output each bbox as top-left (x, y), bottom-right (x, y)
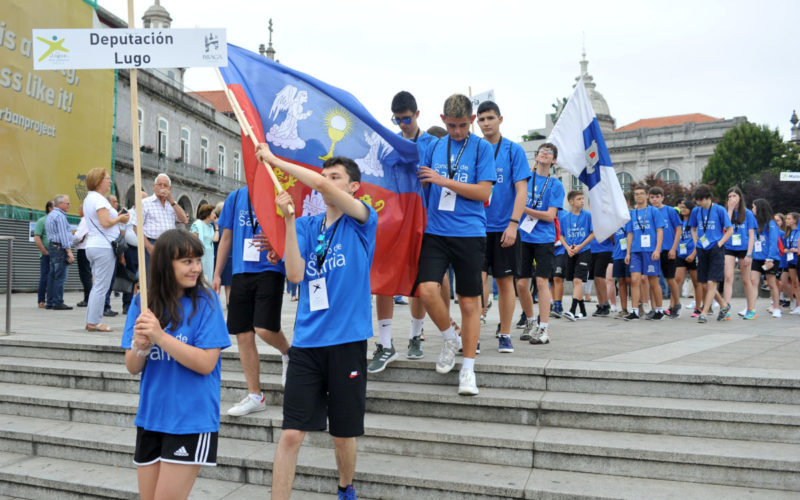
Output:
top-left (99, 0), bottom-right (800, 141)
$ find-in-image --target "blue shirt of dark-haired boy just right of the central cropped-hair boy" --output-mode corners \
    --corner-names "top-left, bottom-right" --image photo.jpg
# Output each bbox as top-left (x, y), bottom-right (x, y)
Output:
top-left (486, 137), bottom-right (531, 232)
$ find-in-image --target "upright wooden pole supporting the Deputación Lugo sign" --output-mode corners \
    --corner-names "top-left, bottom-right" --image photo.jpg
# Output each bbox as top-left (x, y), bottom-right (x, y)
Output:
top-left (128, 0), bottom-right (147, 311)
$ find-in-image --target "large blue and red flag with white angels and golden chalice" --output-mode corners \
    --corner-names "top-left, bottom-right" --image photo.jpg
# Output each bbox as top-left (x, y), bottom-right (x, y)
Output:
top-left (220, 44), bottom-right (426, 295)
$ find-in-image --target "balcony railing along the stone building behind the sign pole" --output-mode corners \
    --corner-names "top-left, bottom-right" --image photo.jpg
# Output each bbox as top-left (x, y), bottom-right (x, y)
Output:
top-left (116, 141), bottom-right (245, 193)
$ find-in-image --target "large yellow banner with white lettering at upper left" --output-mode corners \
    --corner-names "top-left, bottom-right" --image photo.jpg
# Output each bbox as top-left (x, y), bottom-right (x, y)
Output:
top-left (0, 0), bottom-right (114, 214)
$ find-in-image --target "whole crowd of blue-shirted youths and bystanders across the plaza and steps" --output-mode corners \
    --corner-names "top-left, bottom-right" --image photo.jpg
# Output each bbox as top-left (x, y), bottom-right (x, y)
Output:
top-left (36, 92), bottom-right (800, 499)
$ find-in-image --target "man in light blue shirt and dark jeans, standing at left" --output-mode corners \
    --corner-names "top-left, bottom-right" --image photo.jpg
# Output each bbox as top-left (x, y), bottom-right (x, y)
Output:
top-left (45, 194), bottom-right (75, 311)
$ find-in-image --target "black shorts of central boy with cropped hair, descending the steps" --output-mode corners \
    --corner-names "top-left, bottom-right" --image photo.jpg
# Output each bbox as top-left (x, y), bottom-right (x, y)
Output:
top-left (417, 233), bottom-right (486, 297)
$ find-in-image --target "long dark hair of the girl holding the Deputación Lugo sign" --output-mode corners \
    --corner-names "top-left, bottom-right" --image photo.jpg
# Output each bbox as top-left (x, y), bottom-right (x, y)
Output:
top-left (147, 229), bottom-right (209, 328)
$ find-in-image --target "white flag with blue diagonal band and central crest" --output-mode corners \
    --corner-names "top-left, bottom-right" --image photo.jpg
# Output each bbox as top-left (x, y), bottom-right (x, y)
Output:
top-left (547, 77), bottom-right (631, 241)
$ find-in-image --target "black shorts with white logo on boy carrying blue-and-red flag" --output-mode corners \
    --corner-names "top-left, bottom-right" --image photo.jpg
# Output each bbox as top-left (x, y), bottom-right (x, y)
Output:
top-left (283, 340), bottom-right (367, 438)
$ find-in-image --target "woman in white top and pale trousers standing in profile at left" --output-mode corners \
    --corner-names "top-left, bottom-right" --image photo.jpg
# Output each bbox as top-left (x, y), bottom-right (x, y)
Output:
top-left (83, 167), bottom-right (130, 332)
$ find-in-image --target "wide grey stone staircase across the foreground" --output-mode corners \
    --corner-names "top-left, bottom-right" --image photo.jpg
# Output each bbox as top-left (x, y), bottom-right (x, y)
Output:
top-left (0, 335), bottom-right (800, 500)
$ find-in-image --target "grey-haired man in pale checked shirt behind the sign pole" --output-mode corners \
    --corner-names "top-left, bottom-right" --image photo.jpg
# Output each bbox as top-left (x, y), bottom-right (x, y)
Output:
top-left (135, 174), bottom-right (189, 266)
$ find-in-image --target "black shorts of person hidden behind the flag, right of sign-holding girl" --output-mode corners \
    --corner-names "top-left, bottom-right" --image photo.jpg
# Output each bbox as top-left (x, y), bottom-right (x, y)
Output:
top-left (228, 271), bottom-right (286, 335)
